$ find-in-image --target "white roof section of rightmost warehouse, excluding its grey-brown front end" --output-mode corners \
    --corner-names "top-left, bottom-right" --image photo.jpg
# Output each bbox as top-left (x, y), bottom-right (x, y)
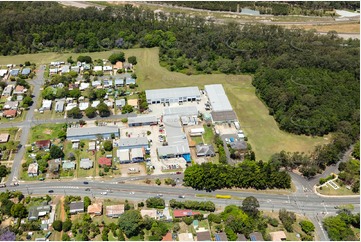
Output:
top-left (204, 84), bottom-right (233, 112)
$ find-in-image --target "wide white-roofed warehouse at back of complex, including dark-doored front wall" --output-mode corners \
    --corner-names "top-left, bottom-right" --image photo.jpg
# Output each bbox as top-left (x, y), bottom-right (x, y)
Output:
top-left (145, 87), bottom-right (201, 104)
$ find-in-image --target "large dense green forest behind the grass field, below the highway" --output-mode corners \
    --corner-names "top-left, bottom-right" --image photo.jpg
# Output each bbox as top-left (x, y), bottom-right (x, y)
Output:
top-left (0, 2), bottom-right (360, 175)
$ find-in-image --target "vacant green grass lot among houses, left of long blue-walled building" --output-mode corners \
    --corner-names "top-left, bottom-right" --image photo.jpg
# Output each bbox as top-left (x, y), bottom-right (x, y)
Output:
top-left (29, 124), bottom-right (64, 143)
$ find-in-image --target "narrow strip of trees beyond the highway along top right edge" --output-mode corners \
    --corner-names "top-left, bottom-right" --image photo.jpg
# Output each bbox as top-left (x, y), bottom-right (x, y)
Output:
top-left (153, 1), bottom-right (360, 16)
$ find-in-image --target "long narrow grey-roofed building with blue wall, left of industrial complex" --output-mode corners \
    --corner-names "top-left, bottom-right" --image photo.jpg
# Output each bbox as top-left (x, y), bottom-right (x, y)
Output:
top-left (66, 126), bottom-right (119, 140)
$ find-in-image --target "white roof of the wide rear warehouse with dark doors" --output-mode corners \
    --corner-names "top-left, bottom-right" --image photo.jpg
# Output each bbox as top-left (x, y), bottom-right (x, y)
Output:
top-left (145, 87), bottom-right (200, 100)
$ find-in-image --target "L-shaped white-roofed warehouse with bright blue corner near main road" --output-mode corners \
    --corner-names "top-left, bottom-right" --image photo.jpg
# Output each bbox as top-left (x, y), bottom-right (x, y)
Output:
top-left (157, 115), bottom-right (191, 162)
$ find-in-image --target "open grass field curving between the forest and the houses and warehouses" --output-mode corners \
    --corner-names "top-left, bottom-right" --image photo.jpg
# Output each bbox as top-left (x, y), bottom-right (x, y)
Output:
top-left (0, 48), bottom-right (328, 160)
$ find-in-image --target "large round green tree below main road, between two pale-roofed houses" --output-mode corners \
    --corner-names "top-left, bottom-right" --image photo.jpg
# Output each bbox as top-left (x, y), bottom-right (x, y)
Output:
top-left (119, 210), bottom-right (142, 238)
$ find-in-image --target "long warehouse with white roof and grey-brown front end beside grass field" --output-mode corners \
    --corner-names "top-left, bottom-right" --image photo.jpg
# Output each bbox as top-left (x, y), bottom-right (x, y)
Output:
top-left (204, 84), bottom-right (237, 123)
